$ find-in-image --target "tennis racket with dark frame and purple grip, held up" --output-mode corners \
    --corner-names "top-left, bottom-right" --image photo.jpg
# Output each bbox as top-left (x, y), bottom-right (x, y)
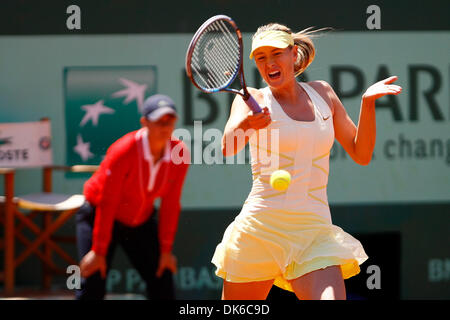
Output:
top-left (186, 15), bottom-right (261, 113)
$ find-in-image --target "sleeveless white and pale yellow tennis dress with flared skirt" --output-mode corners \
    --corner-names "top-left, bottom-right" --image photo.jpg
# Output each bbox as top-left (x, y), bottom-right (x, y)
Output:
top-left (212, 82), bottom-right (368, 291)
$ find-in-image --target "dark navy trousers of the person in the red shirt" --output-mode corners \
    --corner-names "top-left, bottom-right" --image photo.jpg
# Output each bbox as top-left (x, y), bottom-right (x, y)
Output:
top-left (76, 202), bottom-right (175, 300)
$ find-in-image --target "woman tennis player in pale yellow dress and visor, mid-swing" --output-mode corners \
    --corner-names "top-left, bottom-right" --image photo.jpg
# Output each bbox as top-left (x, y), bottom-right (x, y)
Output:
top-left (212, 23), bottom-right (402, 300)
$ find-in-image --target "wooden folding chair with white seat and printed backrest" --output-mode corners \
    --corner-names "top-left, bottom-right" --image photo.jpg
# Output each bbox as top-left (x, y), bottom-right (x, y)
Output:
top-left (0, 119), bottom-right (98, 296)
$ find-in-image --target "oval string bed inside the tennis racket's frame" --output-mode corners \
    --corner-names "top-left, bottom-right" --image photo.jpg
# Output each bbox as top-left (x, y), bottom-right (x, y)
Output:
top-left (190, 20), bottom-right (240, 89)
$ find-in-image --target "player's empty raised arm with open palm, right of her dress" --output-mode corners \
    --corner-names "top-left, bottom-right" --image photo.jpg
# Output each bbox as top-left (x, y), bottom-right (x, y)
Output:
top-left (312, 76), bottom-right (402, 165)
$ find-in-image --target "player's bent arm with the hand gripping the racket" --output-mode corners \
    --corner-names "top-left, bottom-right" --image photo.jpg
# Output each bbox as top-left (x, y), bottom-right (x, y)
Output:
top-left (222, 88), bottom-right (272, 157)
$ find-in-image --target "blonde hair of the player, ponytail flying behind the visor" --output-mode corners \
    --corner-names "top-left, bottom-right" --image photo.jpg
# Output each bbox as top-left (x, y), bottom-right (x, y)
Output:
top-left (252, 22), bottom-right (331, 76)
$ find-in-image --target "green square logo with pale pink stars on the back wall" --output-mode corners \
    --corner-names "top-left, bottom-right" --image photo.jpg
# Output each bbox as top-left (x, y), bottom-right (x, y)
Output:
top-left (65, 66), bottom-right (156, 164)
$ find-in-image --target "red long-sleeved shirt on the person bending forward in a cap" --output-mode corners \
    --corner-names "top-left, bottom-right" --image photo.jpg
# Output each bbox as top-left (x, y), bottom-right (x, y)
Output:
top-left (84, 129), bottom-right (189, 255)
